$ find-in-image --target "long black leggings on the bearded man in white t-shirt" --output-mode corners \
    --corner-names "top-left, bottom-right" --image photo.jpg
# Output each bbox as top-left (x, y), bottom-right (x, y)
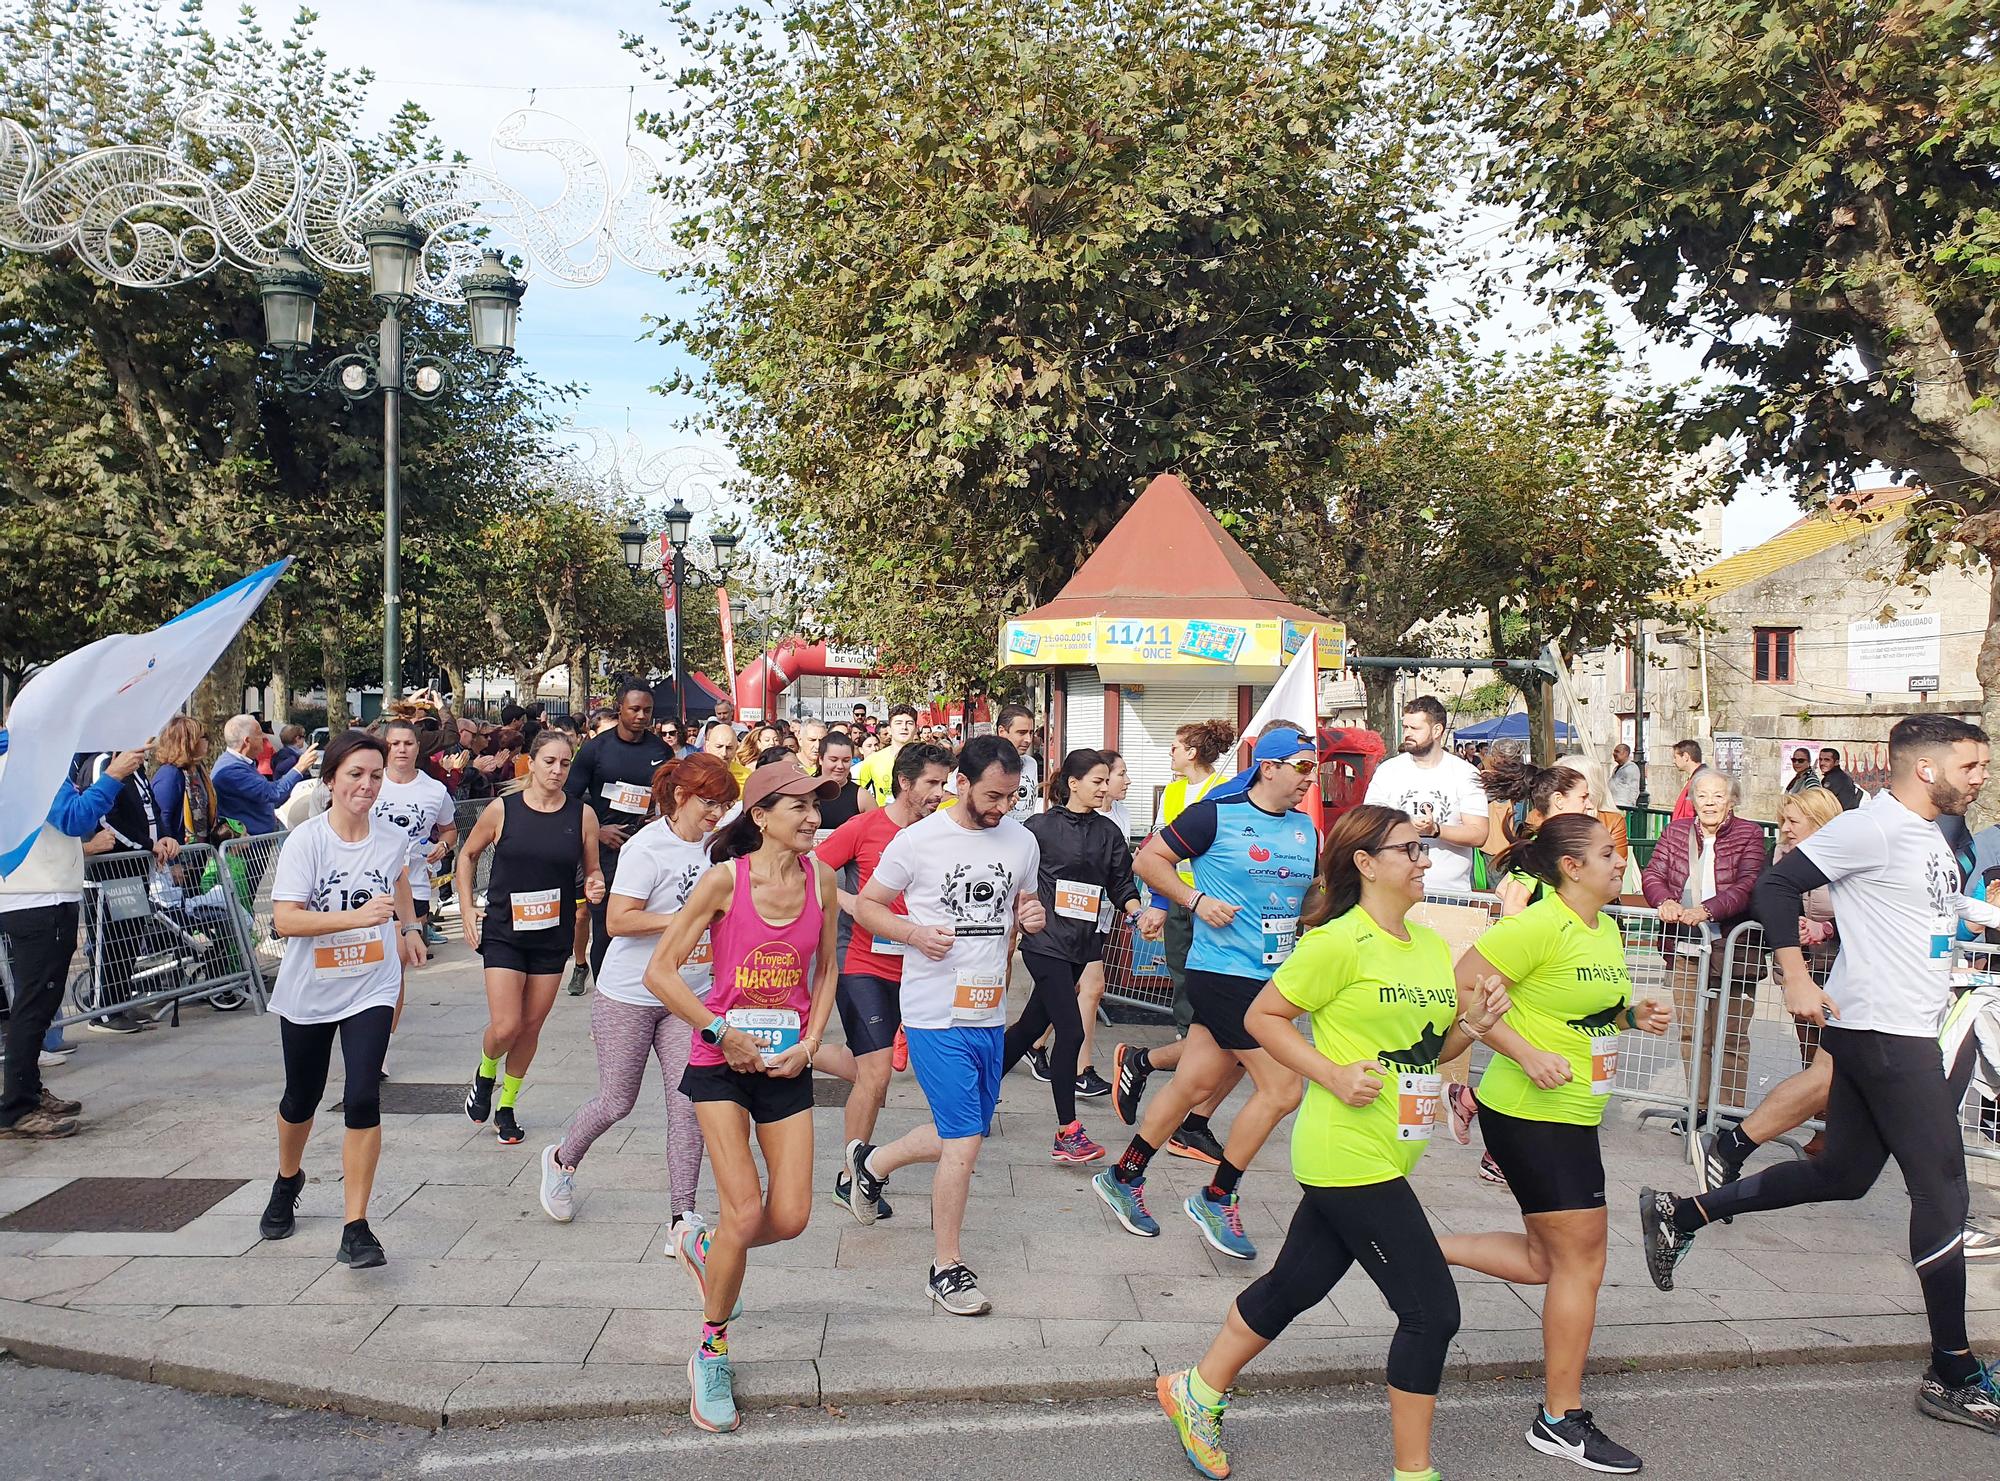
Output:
top-left (1698, 1023), bottom-right (1972, 1353)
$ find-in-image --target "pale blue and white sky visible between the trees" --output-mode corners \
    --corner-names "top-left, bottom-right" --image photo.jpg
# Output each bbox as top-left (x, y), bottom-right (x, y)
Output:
top-left (242, 0), bottom-right (1798, 554)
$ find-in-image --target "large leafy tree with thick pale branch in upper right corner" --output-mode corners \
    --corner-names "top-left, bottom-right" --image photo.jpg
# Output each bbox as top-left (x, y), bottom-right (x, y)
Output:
top-left (1474, 0), bottom-right (2000, 776)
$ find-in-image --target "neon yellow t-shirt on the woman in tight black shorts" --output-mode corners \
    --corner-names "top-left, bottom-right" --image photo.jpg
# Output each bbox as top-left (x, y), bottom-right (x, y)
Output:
top-left (1472, 893), bottom-right (1632, 1127)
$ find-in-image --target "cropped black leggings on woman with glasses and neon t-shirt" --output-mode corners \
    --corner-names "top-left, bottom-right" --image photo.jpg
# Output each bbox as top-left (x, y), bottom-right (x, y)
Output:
top-left (1236, 1177), bottom-right (1458, 1393)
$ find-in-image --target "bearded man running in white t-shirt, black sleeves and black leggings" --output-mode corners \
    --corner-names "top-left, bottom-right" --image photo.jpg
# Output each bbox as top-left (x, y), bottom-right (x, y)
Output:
top-left (1640, 714), bottom-right (2000, 1435)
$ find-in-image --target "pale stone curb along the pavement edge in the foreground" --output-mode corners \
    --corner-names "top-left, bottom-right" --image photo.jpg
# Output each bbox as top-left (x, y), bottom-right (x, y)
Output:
top-left (0, 1301), bottom-right (2000, 1429)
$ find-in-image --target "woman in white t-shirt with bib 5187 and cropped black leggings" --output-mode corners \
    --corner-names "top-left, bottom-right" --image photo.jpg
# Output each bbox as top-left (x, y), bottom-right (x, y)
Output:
top-left (258, 730), bottom-right (426, 1269)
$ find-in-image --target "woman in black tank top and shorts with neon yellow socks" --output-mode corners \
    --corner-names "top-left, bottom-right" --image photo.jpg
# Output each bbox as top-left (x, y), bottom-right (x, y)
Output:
top-left (454, 726), bottom-right (604, 1147)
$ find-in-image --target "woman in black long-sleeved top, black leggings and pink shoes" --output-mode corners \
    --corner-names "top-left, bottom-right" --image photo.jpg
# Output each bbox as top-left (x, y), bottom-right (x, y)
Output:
top-left (1000, 751), bottom-right (1138, 1163)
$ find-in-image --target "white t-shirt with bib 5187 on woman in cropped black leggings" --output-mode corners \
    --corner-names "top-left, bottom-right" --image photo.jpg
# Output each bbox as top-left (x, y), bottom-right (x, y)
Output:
top-left (270, 813), bottom-right (410, 1023)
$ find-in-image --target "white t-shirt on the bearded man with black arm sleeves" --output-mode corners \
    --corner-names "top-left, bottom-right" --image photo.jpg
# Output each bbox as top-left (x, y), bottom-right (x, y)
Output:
top-left (1798, 789), bottom-right (1958, 1039)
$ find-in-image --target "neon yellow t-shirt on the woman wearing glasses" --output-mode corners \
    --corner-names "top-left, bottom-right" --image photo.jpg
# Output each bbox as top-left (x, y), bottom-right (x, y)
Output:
top-left (1270, 905), bottom-right (1458, 1189)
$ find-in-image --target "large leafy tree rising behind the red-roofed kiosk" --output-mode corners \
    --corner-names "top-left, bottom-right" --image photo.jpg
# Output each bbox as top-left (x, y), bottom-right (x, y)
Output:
top-left (630, 0), bottom-right (1444, 690)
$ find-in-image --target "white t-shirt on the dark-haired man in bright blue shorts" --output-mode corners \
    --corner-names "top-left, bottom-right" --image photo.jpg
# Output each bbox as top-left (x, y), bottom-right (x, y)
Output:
top-left (870, 809), bottom-right (1042, 1029)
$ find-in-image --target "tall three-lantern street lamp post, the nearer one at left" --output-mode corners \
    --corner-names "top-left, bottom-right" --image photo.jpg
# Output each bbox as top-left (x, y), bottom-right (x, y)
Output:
top-left (256, 198), bottom-right (526, 708)
